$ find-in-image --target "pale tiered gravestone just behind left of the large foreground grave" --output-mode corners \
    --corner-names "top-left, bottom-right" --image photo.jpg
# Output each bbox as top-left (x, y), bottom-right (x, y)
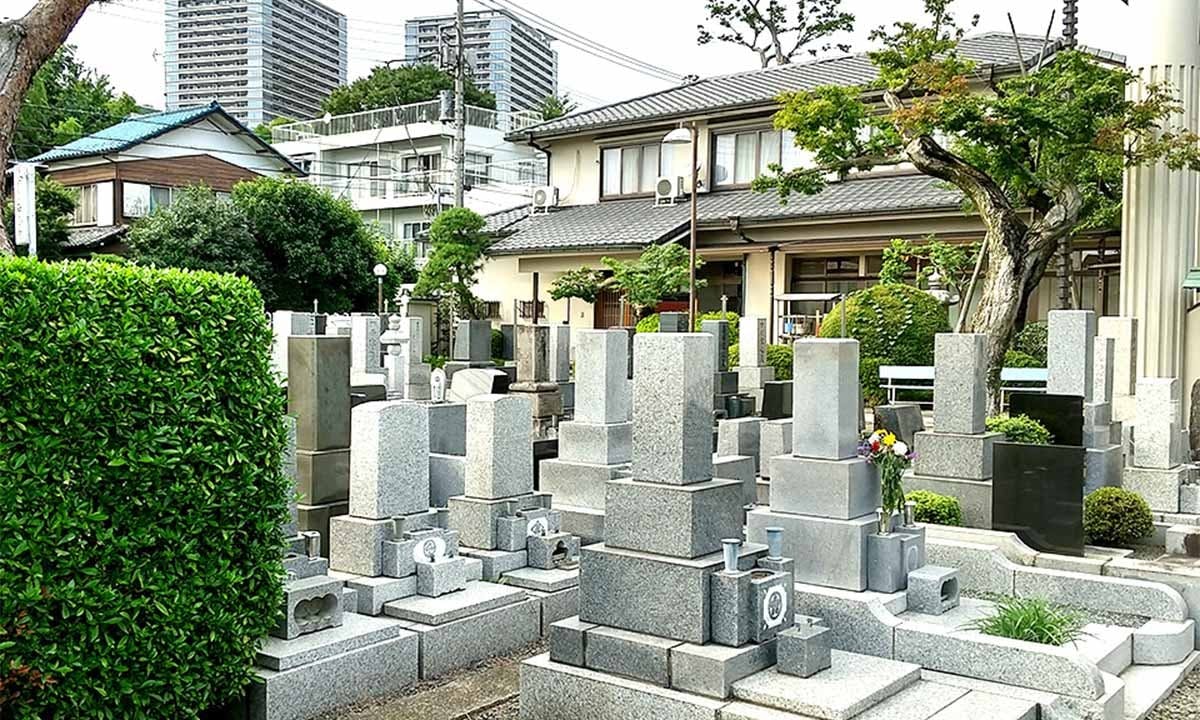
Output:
top-left (539, 329), bottom-right (634, 544)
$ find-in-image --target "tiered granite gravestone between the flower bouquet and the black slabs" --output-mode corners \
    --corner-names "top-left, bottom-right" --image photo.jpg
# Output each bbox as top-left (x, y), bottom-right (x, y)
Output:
top-left (904, 334), bottom-right (1002, 528)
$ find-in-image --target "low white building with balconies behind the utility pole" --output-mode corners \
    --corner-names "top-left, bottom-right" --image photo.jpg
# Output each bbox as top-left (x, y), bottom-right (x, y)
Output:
top-left (272, 101), bottom-right (546, 263)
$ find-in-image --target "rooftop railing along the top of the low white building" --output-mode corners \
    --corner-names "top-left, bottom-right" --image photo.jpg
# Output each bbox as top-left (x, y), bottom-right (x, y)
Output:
top-left (271, 100), bottom-right (541, 143)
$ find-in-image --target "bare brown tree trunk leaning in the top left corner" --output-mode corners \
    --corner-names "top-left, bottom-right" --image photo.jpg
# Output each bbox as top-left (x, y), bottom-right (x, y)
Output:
top-left (0, 0), bottom-right (96, 254)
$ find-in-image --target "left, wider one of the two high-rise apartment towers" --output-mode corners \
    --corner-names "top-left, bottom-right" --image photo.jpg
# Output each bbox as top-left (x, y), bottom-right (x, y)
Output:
top-left (164, 0), bottom-right (347, 127)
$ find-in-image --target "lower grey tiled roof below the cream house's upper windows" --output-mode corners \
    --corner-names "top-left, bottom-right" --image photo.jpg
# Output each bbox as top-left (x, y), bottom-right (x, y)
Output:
top-left (487, 174), bottom-right (962, 254)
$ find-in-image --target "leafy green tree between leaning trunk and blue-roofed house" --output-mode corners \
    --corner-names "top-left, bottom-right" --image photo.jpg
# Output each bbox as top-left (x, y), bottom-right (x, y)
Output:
top-left (12, 46), bottom-right (138, 158)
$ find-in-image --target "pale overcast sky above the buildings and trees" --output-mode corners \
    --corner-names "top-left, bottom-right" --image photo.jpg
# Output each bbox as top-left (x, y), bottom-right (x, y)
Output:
top-left (7, 0), bottom-right (1136, 112)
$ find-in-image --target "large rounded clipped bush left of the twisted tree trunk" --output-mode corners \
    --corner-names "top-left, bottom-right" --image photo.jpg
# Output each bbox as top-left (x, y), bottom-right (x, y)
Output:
top-left (820, 284), bottom-right (950, 404)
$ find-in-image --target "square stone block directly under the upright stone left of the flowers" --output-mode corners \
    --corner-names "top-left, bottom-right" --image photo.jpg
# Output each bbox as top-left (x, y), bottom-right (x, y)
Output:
top-left (770, 455), bottom-right (880, 520)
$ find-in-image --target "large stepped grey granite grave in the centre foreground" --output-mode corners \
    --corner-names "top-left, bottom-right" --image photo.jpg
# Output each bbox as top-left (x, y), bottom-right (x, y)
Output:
top-left (521, 332), bottom-right (950, 720)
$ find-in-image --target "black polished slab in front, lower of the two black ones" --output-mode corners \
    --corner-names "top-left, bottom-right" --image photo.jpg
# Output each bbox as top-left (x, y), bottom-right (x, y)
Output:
top-left (991, 443), bottom-right (1086, 557)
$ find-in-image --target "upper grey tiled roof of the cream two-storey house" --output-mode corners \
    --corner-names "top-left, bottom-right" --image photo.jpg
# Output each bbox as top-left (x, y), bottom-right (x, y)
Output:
top-left (512, 32), bottom-right (1124, 138)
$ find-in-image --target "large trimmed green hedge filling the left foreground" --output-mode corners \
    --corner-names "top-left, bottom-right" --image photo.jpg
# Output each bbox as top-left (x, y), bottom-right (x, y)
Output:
top-left (0, 258), bottom-right (290, 720)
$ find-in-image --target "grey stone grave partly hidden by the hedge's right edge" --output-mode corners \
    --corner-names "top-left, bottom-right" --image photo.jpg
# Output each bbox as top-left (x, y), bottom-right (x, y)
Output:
top-left (246, 418), bottom-right (420, 720)
